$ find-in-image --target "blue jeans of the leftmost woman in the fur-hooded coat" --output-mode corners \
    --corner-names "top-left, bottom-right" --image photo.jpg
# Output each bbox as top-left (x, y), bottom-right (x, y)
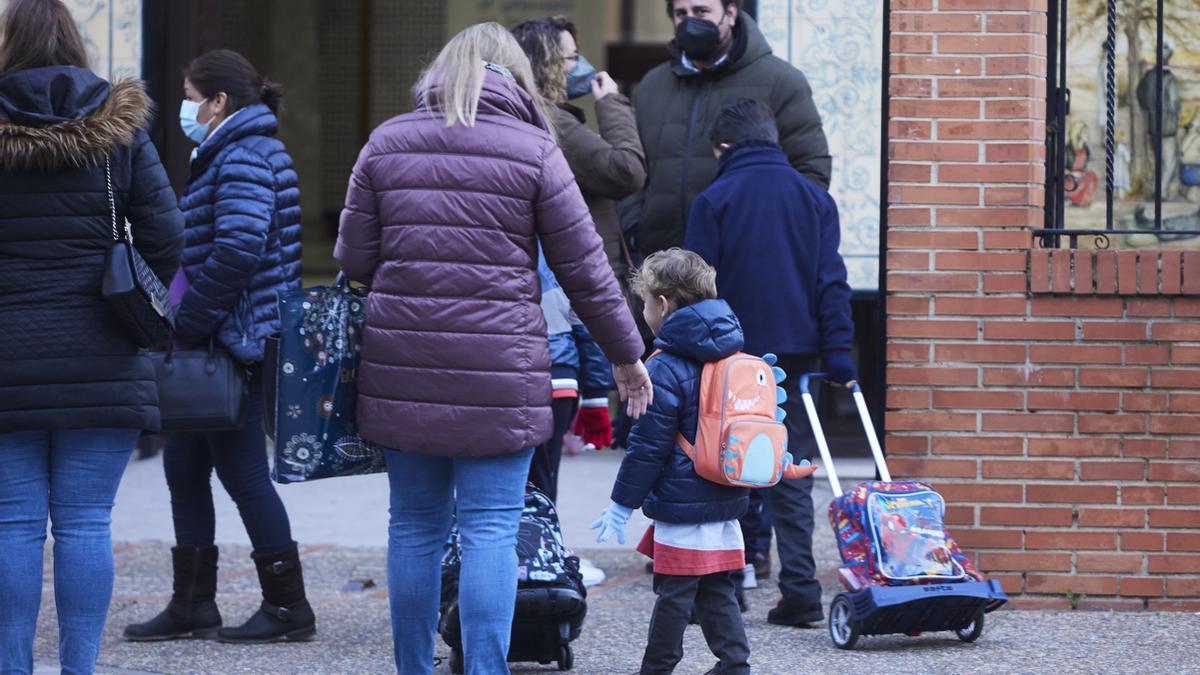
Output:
top-left (0, 429), bottom-right (138, 675)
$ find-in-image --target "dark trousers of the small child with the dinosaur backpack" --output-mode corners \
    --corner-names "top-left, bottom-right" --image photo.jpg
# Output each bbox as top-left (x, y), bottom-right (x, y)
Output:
top-left (641, 572), bottom-right (750, 675)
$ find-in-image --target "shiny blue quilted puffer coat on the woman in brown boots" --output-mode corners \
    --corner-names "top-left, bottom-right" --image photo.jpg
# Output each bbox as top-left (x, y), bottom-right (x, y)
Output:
top-left (175, 103), bottom-right (300, 363)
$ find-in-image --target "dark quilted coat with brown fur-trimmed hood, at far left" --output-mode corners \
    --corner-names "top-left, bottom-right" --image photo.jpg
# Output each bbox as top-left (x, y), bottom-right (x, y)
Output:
top-left (0, 66), bottom-right (184, 427)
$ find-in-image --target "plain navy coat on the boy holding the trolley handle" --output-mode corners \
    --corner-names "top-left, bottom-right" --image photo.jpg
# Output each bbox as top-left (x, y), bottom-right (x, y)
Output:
top-left (684, 141), bottom-right (854, 356)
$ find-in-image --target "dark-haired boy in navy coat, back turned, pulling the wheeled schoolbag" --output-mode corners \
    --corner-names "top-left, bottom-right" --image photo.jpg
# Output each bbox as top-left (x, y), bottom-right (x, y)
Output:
top-left (684, 98), bottom-right (858, 626)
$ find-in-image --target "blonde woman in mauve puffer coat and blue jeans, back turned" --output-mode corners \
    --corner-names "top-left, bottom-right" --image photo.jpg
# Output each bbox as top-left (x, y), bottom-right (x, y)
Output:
top-left (335, 23), bottom-right (650, 674)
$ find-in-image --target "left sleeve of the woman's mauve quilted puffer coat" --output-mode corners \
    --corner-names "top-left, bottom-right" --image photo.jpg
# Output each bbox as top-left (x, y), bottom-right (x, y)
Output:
top-left (334, 143), bottom-right (382, 286)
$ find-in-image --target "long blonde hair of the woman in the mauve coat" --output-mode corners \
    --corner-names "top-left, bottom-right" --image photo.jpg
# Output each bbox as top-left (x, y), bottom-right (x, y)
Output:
top-left (414, 22), bottom-right (553, 133)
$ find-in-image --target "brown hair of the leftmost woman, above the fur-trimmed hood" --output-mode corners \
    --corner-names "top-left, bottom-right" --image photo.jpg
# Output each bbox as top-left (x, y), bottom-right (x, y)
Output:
top-left (0, 0), bottom-right (88, 74)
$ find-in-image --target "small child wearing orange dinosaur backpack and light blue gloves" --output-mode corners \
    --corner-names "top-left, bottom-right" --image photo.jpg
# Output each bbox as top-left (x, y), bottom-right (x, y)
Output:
top-left (592, 249), bottom-right (815, 674)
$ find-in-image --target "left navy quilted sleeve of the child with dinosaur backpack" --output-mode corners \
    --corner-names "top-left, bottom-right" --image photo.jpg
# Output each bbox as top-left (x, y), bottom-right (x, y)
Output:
top-left (612, 357), bottom-right (686, 508)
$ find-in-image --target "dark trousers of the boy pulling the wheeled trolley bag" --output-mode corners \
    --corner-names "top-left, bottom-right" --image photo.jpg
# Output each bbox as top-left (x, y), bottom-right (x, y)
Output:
top-left (767, 354), bottom-right (821, 608)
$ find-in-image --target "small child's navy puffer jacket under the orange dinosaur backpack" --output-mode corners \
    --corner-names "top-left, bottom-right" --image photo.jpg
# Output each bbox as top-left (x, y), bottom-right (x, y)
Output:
top-left (612, 300), bottom-right (750, 524)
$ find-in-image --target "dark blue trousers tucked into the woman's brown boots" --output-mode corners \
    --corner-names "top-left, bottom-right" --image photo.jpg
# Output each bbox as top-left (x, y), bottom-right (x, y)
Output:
top-left (162, 366), bottom-right (292, 552)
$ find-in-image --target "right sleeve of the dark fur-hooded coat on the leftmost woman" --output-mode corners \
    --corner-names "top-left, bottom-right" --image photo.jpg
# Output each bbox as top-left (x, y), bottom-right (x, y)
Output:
top-left (125, 131), bottom-right (184, 283)
